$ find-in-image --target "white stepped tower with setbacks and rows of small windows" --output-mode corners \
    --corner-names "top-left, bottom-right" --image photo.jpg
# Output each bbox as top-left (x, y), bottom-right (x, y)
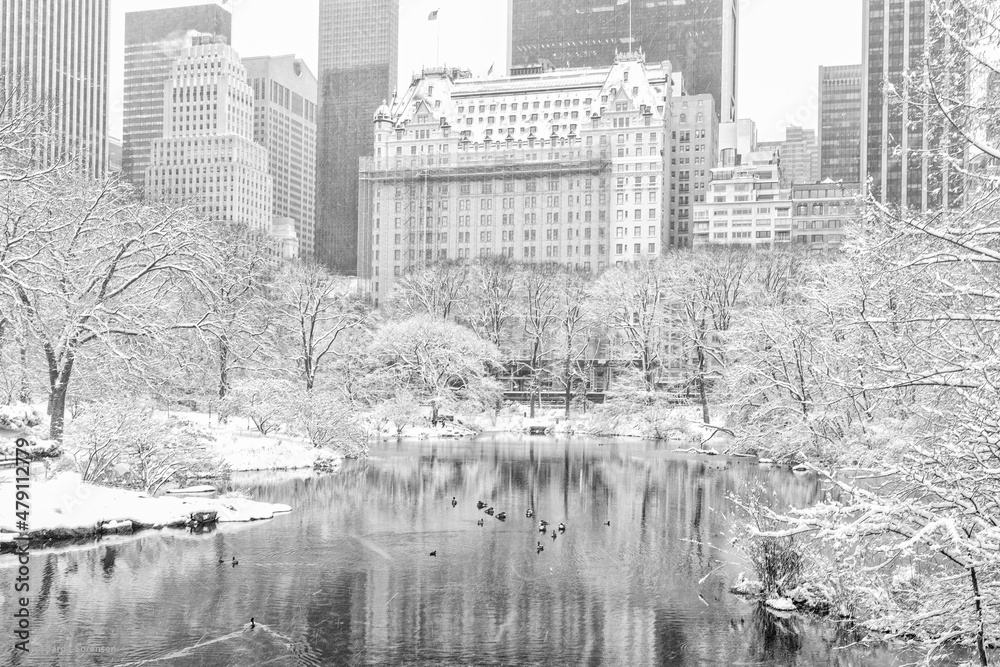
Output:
top-left (145, 37), bottom-right (273, 234)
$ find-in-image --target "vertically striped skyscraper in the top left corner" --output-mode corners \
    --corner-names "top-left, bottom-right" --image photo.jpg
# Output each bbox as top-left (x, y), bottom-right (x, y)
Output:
top-left (0, 0), bottom-right (108, 177)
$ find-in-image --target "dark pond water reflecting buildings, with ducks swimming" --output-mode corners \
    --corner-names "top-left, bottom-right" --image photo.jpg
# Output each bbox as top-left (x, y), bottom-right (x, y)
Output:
top-left (0, 439), bottom-right (920, 667)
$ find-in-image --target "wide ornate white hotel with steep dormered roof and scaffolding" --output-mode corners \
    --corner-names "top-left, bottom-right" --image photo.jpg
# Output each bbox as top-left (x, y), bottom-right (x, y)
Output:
top-left (358, 54), bottom-right (671, 301)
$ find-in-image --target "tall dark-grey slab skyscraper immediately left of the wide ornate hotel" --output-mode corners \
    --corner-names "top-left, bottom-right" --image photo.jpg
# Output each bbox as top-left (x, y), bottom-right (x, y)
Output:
top-left (315, 0), bottom-right (399, 275)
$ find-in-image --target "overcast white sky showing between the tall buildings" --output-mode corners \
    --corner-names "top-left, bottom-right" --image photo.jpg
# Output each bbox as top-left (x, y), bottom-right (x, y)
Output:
top-left (109, 0), bottom-right (861, 141)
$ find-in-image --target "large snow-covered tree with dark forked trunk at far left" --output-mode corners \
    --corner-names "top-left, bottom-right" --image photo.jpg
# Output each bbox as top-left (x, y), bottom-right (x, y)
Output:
top-left (0, 174), bottom-right (210, 440)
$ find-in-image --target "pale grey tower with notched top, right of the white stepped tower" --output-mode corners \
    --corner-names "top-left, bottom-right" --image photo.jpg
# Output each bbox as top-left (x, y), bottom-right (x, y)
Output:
top-left (243, 55), bottom-right (316, 258)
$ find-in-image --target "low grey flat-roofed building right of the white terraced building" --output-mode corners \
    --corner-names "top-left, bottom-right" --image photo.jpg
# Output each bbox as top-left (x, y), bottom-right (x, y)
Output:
top-left (792, 178), bottom-right (861, 250)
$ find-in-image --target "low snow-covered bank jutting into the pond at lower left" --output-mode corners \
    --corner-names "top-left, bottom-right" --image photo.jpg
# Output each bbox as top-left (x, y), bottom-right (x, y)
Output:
top-left (0, 472), bottom-right (291, 541)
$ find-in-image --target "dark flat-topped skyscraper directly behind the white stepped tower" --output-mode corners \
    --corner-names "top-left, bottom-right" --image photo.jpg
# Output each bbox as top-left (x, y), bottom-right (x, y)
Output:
top-left (122, 5), bottom-right (232, 190)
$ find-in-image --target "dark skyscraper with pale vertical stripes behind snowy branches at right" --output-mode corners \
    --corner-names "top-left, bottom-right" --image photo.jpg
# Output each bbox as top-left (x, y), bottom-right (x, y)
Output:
top-left (861, 0), bottom-right (964, 211)
